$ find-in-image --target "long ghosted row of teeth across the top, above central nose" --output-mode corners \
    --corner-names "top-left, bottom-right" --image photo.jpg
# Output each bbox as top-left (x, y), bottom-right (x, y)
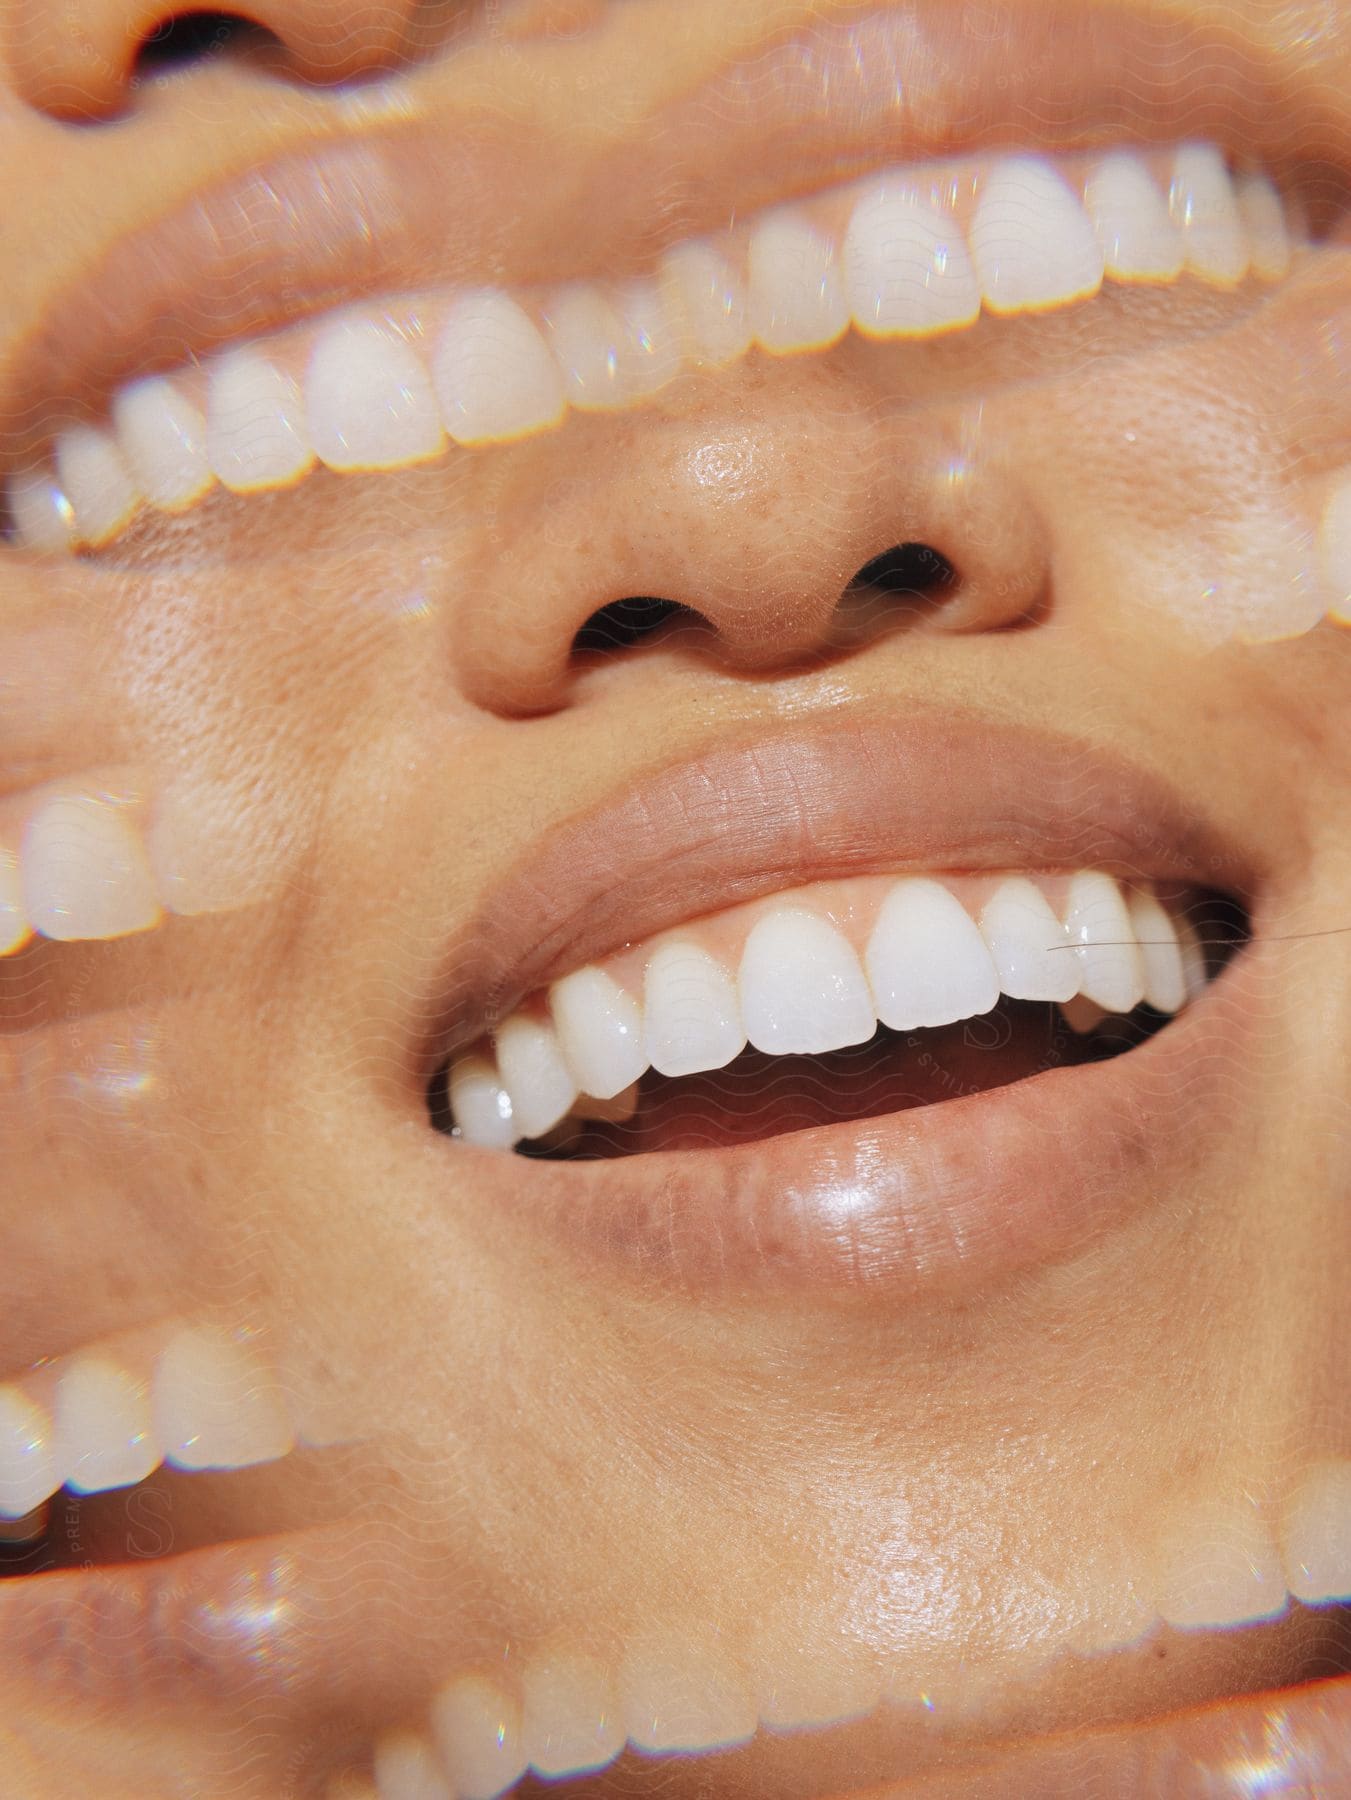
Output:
top-left (9, 144), bottom-right (1290, 551)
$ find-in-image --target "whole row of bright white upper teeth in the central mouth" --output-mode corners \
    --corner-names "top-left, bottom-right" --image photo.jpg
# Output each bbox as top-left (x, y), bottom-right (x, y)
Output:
top-left (448, 869), bottom-right (1205, 1148)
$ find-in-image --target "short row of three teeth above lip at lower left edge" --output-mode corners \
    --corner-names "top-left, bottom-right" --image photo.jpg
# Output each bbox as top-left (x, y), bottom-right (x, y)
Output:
top-left (0, 1325), bottom-right (295, 1537)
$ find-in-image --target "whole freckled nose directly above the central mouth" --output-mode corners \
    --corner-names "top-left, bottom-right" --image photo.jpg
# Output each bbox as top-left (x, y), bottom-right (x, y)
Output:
top-left (453, 364), bottom-right (1049, 715)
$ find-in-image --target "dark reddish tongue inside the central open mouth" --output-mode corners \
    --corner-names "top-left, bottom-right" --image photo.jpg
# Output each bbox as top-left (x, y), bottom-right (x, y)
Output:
top-left (618, 1001), bottom-right (1094, 1156)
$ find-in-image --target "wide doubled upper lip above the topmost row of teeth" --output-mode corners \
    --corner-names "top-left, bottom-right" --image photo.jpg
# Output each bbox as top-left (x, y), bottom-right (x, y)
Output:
top-left (0, 0), bottom-right (1351, 461)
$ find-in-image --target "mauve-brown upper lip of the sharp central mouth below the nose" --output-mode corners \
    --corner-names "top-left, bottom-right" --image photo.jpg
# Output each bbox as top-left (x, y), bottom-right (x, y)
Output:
top-left (419, 698), bottom-right (1266, 1075)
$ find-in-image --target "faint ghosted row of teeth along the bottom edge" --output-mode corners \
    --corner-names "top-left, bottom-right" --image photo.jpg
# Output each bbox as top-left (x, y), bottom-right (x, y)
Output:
top-left (350, 1460), bottom-right (1351, 1800)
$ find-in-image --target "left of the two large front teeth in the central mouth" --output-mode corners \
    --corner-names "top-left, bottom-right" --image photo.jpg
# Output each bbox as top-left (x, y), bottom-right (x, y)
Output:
top-left (739, 907), bottom-right (878, 1057)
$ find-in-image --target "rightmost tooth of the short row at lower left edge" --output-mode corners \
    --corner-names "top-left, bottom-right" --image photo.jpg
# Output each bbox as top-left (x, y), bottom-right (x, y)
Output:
top-left (151, 1327), bottom-right (295, 1469)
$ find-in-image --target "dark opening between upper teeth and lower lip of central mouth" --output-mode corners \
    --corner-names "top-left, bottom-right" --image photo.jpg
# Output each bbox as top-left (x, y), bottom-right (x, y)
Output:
top-left (428, 895), bottom-right (1248, 1161)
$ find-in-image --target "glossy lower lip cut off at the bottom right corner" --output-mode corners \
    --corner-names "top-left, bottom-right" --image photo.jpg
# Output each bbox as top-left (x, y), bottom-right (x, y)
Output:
top-left (831, 1678), bottom-right (1351, 1800)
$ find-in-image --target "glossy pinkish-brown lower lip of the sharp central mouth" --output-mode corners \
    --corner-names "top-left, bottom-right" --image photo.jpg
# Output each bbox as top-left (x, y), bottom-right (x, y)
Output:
top-left (444, 921), bottom-right (1270, 1303)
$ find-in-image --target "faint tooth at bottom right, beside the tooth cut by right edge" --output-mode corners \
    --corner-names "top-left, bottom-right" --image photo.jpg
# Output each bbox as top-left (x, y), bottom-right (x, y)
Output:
top-left (1159, 1501), bottom-right (1286, 1629)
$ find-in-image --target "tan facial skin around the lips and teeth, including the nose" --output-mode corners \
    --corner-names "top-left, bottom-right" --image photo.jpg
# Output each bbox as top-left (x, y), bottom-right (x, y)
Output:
top-left (0, 0), bottom-right (1351, 1796)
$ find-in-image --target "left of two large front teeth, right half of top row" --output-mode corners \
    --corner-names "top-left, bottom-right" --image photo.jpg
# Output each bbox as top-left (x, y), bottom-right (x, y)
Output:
top-left (844, 175), bottom-right (980, 337)
